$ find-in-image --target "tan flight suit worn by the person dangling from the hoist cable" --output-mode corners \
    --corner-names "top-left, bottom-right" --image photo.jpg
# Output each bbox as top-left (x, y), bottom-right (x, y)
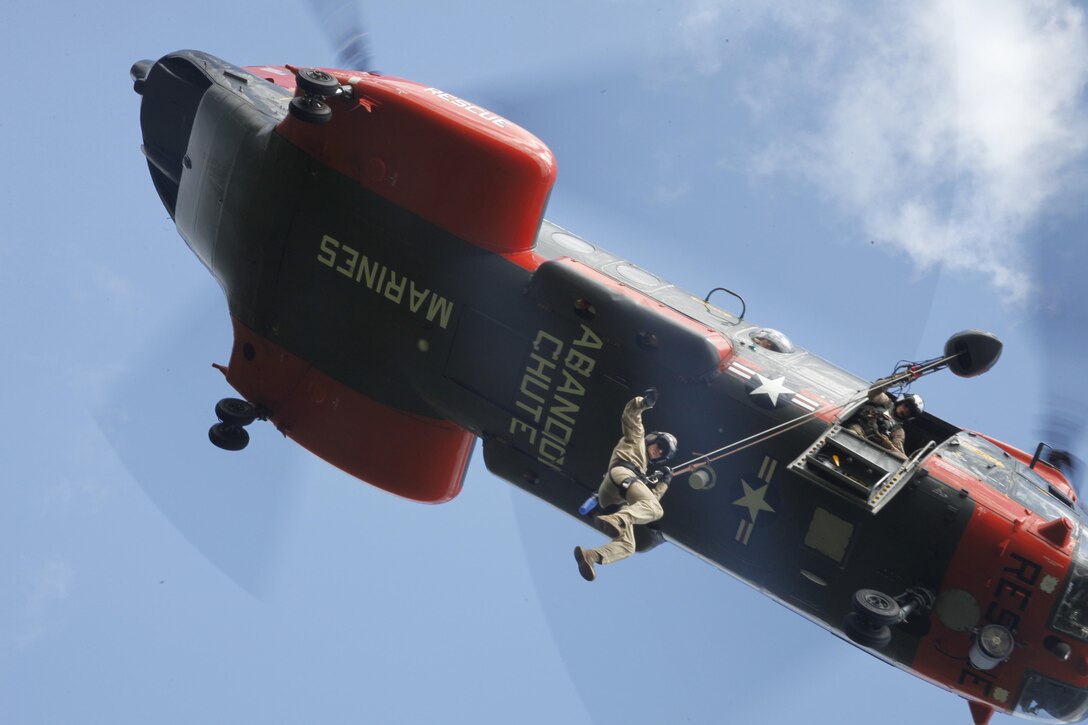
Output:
top-left (586, 395), bottom-right (669, 564)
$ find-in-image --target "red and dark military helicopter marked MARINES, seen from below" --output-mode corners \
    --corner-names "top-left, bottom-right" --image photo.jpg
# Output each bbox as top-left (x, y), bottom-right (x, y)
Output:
top-left (133, 40), bottom-right (1086, 722)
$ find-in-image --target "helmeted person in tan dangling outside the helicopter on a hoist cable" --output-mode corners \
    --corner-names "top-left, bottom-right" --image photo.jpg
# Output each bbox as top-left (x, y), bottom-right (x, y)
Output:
top-left (574, 388), bottom-right (677, 581)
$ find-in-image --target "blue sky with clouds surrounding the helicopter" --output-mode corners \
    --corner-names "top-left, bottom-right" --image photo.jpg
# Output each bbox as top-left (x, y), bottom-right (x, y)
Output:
top-left (0, 0), bottom-right (1088, 725)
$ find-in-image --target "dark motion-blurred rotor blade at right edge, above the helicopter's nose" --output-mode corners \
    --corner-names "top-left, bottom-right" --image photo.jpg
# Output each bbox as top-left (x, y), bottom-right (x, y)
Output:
top-left (1034, 211), bottom-right (1088, 495)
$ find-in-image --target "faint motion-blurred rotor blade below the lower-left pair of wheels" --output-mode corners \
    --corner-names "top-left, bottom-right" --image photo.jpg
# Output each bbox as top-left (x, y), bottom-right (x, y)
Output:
top-left (95, 285), bottom-right (298, 598)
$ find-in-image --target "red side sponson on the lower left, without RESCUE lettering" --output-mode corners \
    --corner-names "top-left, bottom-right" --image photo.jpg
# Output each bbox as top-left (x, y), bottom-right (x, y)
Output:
top-left (220, 320), bottom-right (475, 503)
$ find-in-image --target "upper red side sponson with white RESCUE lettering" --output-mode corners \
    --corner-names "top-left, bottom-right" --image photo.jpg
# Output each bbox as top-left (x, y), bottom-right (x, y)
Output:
top-left (271, 66), bottom-right (556, 262)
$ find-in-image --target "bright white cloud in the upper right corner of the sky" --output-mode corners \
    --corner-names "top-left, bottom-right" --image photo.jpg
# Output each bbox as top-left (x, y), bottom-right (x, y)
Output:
top-left (680, 0), bottom-right (1088, 299)
